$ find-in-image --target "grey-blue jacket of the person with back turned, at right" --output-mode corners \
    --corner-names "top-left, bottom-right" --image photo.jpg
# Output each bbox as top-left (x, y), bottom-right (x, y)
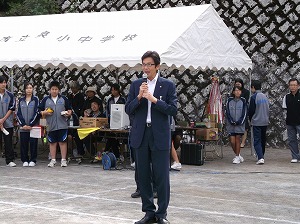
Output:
top-left (249, 90), bottom-right (269, 126)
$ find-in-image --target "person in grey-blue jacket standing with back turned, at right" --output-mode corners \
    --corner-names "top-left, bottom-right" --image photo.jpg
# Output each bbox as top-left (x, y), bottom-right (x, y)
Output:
top-left (249, 80), bottom-right (269, 165)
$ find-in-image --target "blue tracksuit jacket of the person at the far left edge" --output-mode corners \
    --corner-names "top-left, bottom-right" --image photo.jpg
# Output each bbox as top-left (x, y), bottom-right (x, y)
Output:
top-left (0, 90), bottom-right (16, 128)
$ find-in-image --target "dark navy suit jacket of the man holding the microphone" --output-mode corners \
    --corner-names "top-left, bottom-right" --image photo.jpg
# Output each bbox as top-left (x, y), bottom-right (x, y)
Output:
top-left (125, 77), bottom-right (177, 150)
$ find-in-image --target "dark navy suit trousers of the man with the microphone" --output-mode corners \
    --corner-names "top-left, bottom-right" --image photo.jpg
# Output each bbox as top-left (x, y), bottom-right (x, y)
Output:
top-left (135, 127), bottom-right (170, 218)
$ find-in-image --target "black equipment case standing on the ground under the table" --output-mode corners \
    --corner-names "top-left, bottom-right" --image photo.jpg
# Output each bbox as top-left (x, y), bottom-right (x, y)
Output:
top-left (180, 143), bottom-right (204, 166)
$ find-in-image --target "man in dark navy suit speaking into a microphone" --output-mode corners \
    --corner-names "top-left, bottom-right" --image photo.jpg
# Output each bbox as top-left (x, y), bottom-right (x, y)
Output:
top-left (125, 51), bottom-right (177, 224)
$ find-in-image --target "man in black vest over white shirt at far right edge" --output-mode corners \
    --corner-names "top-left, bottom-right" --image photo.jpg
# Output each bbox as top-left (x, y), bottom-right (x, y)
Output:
top-left (282, 78), bottom-right (300, 163)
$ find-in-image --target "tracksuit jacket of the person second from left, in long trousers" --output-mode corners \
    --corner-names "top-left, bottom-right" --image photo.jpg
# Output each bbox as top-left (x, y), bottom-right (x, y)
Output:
top-left (17, 96), bottom-right (40, 132)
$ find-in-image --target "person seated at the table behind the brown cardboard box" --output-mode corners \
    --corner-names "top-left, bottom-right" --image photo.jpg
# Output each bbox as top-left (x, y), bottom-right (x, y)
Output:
top-left (83, 100), bottom-right (103, 158)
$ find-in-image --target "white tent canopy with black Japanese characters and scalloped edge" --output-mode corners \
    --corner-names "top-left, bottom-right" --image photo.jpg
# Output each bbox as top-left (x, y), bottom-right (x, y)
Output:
top-left (0, 5), bottom-right (252, 70)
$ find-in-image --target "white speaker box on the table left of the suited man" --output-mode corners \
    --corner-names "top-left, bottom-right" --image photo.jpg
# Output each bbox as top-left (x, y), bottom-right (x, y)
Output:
top-left (110, 104), bottom-right (129, 129)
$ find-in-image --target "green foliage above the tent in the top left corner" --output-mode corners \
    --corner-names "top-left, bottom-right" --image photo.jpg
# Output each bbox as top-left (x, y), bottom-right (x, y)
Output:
top-left (0, 0), bottom-right (60, 16)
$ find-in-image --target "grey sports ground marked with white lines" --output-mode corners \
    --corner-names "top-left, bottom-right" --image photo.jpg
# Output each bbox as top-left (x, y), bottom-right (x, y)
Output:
top-left (0, 144), bottom-right (300, 224)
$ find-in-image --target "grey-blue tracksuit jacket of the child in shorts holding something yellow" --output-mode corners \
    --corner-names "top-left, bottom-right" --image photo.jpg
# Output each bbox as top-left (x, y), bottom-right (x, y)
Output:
top-left (39, 95), bottom-right (72, 131)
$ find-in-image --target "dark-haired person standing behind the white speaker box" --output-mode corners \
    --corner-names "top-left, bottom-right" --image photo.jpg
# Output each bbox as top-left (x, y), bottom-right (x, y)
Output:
top-left (105, 83), bottom-right (126, 159)
